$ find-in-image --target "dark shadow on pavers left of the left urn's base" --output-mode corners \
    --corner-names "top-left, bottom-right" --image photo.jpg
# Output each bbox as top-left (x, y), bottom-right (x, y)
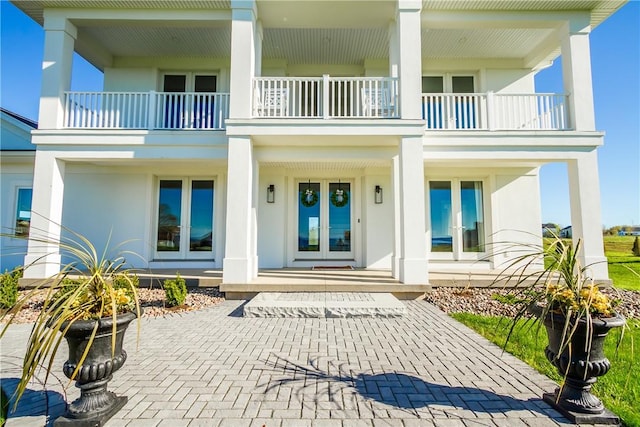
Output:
top-left (0, 378), bottom-right (67, 427)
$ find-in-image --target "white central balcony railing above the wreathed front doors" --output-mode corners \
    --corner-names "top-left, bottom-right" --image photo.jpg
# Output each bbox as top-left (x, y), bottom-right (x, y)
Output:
top-left (253, 75), bottom-right (400, 119)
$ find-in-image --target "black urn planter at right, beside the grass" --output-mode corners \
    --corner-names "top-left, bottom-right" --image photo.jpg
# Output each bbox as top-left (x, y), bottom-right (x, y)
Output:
top-left (543, 313), bottom-right (625, 424)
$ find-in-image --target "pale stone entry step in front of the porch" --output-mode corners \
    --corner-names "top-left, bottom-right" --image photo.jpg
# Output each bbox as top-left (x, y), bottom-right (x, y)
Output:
top-left (244, 292), bottom-right (407, 318)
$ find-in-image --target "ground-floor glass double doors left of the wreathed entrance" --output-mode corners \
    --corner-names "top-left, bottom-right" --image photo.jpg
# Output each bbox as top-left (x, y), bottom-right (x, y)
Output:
top-left (155, 178), bottom-right (214, 259)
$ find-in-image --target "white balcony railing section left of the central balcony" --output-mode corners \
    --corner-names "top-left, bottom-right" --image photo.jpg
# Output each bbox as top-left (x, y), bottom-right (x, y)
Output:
top-left (64, 92), bottom-right (229, 130)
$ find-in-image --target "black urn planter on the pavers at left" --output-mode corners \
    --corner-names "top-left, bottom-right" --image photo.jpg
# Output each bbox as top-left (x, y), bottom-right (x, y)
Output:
top-left (54, 312), bottom-right (136, 427)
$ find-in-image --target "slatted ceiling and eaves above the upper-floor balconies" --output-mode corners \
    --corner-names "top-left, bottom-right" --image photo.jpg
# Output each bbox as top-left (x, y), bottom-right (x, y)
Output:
top-left (12, 0), bottom-right (625, 69)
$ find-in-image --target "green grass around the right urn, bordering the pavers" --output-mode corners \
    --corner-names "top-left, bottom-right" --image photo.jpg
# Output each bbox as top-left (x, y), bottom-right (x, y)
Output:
top-left (451, 313), bottom-right (640, 427)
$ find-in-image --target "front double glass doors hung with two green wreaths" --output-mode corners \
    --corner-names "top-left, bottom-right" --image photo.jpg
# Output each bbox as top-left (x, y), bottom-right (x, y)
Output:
top-left (295, 180), bottom-right (354, 260)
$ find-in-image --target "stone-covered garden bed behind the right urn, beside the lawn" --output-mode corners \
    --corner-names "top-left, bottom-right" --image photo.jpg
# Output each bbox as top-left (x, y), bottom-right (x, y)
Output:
top-left (425, 287), bottom-right (640, 319)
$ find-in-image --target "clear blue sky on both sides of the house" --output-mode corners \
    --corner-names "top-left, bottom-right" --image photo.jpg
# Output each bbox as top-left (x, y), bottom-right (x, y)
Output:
top-left (0, 0), bottom-right (640, 227)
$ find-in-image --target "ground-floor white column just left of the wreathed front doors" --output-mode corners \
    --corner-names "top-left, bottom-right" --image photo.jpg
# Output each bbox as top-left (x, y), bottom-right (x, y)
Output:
top-left (222, 137), bottom-right (256, 283)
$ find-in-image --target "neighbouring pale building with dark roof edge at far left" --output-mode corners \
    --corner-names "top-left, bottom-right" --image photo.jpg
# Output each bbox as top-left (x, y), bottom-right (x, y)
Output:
top-left (0, 108), bottom-right (38, 272)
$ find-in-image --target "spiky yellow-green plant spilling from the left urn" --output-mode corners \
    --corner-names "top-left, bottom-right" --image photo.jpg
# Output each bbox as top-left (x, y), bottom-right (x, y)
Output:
top-left (0, 225), bottom-right (141, 409)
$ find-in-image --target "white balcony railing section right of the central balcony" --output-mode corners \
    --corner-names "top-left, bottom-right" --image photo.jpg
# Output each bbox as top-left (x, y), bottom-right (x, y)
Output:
top-left (422, 92), bottom-right (569, 130)
